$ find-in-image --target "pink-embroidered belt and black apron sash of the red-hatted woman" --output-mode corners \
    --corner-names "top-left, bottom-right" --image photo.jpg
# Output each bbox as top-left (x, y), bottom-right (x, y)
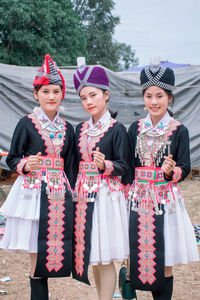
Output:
top-left (23, 156), bottom-right (72, 277)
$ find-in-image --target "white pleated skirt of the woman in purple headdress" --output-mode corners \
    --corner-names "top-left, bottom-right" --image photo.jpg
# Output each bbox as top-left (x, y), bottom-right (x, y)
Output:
top-left (90, 180), bottom-right (129, 265)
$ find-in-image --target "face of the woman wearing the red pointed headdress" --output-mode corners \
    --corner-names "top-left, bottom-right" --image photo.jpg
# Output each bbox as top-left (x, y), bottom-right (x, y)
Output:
top-left (33, 84), bottom-right (62, 121)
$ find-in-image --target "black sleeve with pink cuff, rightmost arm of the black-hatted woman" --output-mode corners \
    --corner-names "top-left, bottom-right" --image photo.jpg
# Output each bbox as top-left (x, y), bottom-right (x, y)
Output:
top-left (166, 125), bottom-right (191, 182)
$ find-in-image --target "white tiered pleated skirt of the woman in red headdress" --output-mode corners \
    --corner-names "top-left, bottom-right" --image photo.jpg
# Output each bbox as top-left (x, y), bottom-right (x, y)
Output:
top-left (0, 175), bottom-right (40, 253)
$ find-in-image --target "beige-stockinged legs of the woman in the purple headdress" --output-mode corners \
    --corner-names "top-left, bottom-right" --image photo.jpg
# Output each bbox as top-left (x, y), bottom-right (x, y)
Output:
top-left (98, 262), bottom-right (117, 300)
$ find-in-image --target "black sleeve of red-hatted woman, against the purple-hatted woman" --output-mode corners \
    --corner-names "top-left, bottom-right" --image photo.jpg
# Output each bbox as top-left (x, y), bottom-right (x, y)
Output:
top-left (64, 123), bottom-right (78, 189)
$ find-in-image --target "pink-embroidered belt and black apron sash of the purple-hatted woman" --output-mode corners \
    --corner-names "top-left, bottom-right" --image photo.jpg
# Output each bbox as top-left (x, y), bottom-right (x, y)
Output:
top-left (72, 161), bottom-right (123, 284)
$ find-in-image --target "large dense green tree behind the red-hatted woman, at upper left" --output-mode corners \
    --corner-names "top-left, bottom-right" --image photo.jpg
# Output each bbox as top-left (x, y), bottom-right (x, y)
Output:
top-left (0, 0), bottom-right (87, 65)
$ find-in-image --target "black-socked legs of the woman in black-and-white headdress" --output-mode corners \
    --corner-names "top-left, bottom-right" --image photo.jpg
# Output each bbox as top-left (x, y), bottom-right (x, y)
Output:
top-left (152, 267), bottom-right (173, 300)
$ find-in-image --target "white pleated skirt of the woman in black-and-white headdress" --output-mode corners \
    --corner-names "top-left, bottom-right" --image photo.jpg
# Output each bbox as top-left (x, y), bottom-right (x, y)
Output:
top-left (164, 183), bottom-right (199, 266)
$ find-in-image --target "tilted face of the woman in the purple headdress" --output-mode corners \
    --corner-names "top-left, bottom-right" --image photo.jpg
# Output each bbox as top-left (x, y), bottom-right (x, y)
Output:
top-left (80, 86), bottom-right (109, 121)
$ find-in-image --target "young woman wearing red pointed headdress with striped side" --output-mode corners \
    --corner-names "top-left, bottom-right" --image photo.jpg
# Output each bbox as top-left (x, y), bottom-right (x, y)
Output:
top-left (0, 54), bottom-right (76, 300)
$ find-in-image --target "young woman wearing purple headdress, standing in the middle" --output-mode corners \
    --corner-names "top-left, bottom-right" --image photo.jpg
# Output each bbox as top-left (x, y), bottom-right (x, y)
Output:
top-left (73, 59), bottom-right (129, 300)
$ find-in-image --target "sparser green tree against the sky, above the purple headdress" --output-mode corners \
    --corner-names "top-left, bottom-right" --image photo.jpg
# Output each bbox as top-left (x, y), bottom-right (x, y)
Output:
top-left (73, 0), bottom-right (138, 71)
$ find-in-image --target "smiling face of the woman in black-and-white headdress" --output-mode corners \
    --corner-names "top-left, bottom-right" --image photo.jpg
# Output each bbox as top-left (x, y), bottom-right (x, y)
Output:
top-left (144, 86), bottom-right (173, 125)
